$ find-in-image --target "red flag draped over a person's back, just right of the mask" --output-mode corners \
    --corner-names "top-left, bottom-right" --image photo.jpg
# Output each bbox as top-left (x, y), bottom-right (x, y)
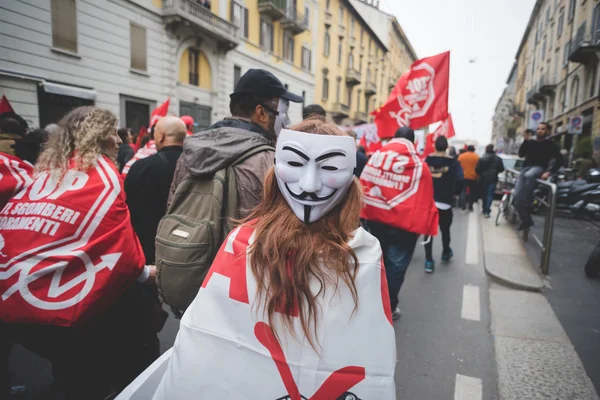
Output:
top-left (360, 139), bottom-right (438, 235)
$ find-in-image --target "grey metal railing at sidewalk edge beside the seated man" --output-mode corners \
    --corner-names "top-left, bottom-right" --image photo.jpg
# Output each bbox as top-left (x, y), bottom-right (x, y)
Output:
top-left (506, 168), bottom-right (556, 275)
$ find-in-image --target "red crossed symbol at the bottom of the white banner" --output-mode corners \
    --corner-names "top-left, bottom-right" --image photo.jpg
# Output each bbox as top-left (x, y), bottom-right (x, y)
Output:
top-left (254, 322), bottom-right (365, 400)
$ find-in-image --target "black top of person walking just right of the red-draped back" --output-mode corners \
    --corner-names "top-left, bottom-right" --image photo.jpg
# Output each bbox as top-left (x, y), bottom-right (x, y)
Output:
top-left (425, 155), bottom-right (465, 204)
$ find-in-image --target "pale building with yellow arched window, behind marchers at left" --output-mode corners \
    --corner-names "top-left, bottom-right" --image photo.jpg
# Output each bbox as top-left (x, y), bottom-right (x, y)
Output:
top-left (0, 0), bottom-right (317, 129)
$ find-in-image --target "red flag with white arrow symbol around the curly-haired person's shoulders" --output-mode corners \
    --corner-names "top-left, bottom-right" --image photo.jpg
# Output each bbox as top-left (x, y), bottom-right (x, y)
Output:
top-left (0, 156), bottom-right (144, 326)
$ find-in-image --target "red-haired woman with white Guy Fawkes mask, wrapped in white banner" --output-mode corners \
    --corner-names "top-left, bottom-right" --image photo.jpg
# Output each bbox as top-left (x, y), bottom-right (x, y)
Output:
top-left (132, 120), bottom-right (396, 400)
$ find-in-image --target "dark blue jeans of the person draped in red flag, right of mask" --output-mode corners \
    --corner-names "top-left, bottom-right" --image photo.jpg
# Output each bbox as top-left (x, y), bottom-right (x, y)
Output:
top-left (367, 221), bottom-right (419, 311)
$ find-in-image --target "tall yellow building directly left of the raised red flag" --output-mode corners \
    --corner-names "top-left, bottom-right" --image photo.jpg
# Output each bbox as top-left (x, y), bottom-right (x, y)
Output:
top-left (315, 0), bottom-right (416, 125)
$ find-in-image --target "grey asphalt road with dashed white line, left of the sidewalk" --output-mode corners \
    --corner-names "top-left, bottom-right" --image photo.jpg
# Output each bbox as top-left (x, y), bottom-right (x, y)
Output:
top-left (11, 211), bottom-right (498, 400)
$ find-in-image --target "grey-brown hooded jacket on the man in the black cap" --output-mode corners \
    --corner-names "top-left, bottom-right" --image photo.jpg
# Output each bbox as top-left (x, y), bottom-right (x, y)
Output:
top-left (166, 118), bottom-right (275, 219)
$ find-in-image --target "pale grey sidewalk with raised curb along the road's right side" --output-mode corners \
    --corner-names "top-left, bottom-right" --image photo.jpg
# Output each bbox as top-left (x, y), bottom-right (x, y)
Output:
top-left (480, 211), bottom-right (598, 400)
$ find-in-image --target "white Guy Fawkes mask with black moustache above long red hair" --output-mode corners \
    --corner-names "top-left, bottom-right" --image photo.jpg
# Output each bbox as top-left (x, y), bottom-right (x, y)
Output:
top-left (275, 129), bottom-right (356, 224)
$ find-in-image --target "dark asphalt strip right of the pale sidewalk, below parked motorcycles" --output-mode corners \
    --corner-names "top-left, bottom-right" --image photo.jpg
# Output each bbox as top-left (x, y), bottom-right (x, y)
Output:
top-left (526, 216), bottom-right (600, 392)
